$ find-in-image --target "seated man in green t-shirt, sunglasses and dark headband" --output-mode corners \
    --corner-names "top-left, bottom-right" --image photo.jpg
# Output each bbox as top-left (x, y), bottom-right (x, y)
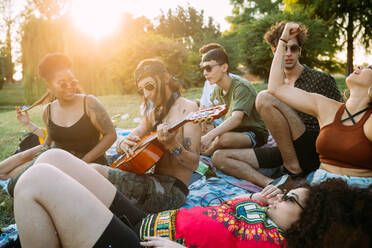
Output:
top-left (200, 49), bottom-right (268, 160)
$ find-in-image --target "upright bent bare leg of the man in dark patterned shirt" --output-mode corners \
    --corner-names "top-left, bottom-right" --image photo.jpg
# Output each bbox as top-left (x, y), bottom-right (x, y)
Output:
top-left (256, 91), bottom-right (305, 173)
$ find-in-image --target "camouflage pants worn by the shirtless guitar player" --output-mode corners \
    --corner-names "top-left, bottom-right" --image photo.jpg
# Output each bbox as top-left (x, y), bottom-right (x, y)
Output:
top-left (108, 168), bottom-right (187, 213)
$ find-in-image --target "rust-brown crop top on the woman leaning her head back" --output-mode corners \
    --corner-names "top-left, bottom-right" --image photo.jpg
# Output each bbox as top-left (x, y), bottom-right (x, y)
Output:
top-left (316, 104), bottom-right (372, 170)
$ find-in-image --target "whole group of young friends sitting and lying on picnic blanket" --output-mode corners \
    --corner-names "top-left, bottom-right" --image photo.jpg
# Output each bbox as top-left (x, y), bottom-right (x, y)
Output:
top-left (0, 22), bottom-right (372, 248)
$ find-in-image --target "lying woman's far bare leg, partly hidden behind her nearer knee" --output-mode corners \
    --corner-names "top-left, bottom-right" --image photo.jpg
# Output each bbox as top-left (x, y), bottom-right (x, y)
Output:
top-left (35, 149), bottom-right (116, 207)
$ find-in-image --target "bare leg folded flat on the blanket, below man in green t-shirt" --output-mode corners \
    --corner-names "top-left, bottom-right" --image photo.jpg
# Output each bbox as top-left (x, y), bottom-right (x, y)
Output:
top-left (212, 149), bottom-right (273, 187)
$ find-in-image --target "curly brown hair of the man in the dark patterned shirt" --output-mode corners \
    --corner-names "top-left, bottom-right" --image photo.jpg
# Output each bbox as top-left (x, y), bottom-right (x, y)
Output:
top-left (264, 22), bottom-right (307, 47)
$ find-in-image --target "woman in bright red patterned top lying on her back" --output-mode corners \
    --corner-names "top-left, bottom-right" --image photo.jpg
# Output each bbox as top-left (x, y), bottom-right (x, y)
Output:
top-left (14, 156), bottom-right (372, 248)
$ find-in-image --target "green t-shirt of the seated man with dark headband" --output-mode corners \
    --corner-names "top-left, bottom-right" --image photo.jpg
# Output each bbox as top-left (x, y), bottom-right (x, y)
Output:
top-left (211, 77), bottom-right (268, 137)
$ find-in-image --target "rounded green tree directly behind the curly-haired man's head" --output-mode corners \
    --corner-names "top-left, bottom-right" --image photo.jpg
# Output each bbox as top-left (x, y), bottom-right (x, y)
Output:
top-left (231, 12), bottom-right (339, 79)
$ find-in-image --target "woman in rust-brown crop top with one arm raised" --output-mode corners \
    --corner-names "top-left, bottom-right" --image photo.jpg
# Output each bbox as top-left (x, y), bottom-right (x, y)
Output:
top-left (268, 23), bottom-right (372, 187)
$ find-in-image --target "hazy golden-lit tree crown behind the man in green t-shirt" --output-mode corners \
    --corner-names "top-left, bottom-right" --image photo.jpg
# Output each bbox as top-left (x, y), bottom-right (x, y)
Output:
top-left (155, 6), bottom-right (220, 51)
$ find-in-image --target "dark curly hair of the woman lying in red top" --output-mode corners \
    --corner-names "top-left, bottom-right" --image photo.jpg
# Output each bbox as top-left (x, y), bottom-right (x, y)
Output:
top-left (285, 179), bottom-right (372, 248)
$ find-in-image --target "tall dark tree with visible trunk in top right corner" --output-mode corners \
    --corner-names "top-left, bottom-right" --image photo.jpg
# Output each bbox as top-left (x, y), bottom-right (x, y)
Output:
top-left (287, 0), bottom-right (372, 75)
